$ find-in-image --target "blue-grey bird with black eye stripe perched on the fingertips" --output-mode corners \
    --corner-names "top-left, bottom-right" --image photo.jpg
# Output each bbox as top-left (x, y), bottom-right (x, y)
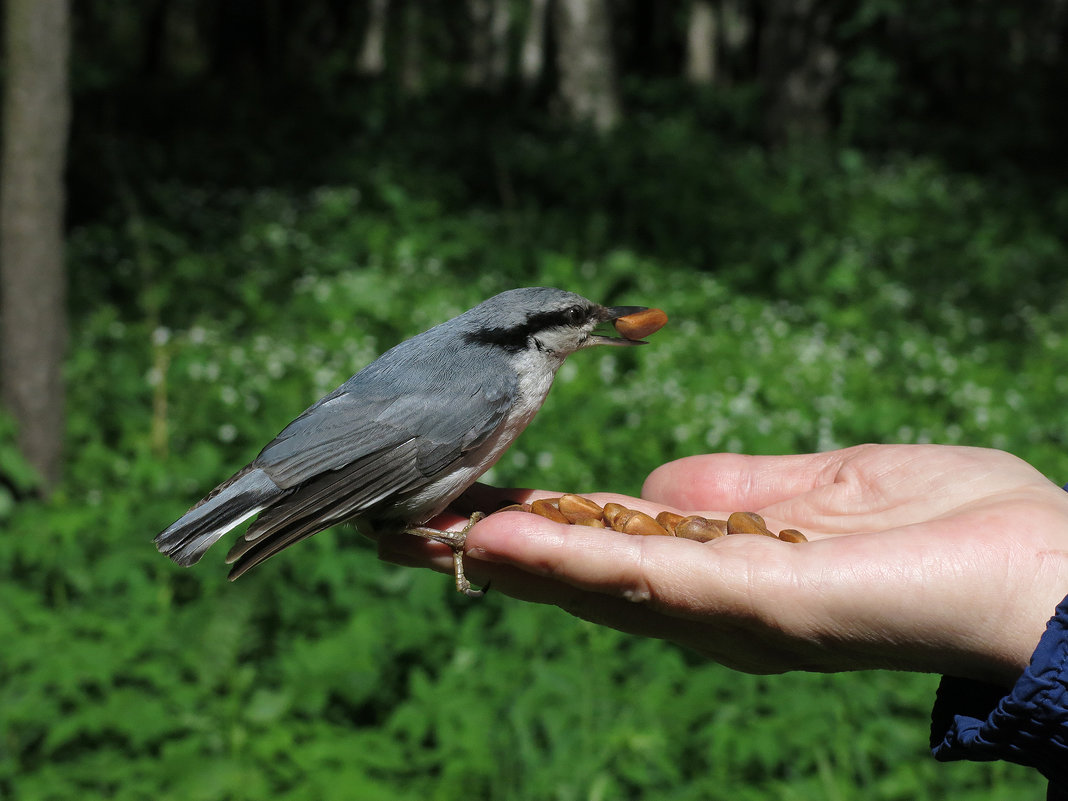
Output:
top-left (155, 287), bottom-right (645, 597)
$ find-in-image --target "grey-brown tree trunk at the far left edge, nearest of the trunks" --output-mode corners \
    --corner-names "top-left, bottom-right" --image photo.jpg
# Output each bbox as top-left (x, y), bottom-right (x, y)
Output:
top-left (0, 0), bottom-right (70, 486)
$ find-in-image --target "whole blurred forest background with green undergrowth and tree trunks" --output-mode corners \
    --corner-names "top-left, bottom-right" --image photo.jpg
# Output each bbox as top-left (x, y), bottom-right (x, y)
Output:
top-left (0, 0), bottom-right (1068, 801)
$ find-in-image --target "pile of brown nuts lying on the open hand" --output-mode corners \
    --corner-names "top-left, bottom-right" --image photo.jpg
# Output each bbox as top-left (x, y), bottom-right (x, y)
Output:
top-left (498, 494), bottom-right (808, 543)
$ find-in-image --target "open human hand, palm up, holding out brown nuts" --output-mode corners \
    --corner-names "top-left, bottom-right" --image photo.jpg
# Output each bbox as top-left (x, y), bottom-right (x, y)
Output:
top-left (380, 445), bottom-right (1068, 685)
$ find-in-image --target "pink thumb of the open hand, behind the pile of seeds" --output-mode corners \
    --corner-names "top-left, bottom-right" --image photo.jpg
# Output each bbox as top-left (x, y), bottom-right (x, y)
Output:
top-left (642, 449), bottom-right (852, 511)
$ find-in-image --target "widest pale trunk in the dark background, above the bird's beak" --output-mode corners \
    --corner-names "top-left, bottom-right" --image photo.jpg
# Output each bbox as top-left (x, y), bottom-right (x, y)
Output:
top-left (554, 0), bottom-right (621, 134)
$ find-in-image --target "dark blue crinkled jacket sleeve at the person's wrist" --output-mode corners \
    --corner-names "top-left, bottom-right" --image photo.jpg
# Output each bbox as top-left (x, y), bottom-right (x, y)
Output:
top-left (931, 598), bottom-right (1068, 798)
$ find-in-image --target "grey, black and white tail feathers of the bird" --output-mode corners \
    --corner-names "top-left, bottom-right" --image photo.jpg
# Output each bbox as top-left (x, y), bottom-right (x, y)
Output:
top-left (155, 467), bottom-right (286, 567)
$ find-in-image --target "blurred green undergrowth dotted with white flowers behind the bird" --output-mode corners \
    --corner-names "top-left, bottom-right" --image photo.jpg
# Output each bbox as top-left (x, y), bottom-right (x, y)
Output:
top-left (6, 26), bottom-right (1068, 801)
